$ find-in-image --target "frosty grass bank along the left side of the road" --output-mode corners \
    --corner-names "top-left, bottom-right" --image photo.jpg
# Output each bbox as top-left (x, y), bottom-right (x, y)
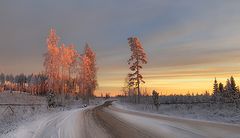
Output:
top-left (0, 91), bottom-right (102, 137)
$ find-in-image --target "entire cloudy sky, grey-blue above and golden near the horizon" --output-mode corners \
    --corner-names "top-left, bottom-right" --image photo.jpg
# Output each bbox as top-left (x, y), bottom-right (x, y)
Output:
top-left (0, 0), bottom-right (240, 95)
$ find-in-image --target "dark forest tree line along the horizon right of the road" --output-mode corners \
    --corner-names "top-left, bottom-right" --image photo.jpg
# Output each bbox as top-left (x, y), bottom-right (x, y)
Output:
top-left (119, 76), bottom-right (240, 108)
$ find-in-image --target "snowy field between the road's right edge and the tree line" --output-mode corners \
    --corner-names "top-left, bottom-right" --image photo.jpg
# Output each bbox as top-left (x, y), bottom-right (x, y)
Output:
top-left (117, 102), bottom-right (240, 124)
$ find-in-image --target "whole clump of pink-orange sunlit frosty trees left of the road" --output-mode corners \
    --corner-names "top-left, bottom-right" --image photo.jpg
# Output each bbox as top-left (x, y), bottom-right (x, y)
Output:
top-left (44, 29), bottom-right (97, 95)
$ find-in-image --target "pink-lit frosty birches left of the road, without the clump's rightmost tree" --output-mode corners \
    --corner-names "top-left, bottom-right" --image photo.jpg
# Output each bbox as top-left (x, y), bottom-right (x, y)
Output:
top-left (44, 29), bottom-right (78, 93)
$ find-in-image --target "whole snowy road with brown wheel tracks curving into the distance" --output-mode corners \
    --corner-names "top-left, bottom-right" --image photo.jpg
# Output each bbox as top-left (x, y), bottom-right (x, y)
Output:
top-left (10, 102), bottom-right (240, 138)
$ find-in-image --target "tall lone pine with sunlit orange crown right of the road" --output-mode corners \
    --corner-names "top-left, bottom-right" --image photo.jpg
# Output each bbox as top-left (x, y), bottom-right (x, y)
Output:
top-left (128, 37), bottom-right (147, 103)
